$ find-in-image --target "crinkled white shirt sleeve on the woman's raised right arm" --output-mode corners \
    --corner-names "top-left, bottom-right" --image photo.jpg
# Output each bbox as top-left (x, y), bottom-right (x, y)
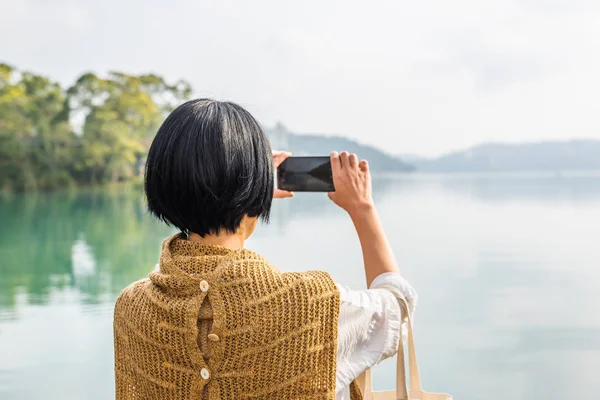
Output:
top-left (336, 273), bottom-right (417, 400)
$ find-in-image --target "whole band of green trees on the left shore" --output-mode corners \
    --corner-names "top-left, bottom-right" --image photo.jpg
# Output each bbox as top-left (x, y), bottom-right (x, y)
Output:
top-left (0, 64), bottom-right (191, 191)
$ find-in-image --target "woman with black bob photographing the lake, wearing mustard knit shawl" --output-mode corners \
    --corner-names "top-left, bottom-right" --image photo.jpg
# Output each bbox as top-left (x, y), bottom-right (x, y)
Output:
top-left (114, 99), bottom-right (416, 400)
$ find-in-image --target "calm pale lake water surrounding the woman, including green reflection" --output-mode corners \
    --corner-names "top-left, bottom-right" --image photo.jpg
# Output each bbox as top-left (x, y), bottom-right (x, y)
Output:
top-left (0, 175), bottom-right (600, 400)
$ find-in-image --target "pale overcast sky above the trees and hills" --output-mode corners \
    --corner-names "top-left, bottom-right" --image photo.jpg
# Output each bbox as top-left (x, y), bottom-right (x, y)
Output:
top-left (0, 0), bottom-right (600, 156)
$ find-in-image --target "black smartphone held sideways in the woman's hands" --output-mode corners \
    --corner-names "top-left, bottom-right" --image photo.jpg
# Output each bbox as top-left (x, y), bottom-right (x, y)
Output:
top-left (277, 156), bottom-right (335, 192)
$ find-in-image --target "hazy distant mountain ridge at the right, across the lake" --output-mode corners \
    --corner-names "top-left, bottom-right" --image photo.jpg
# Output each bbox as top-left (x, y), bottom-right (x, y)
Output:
top-left (410, 140), bottom-right (600, 172)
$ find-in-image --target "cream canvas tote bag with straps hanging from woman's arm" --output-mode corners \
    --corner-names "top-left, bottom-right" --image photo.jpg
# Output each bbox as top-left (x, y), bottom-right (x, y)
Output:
top-left (357, 299), bottom-right (452, 400)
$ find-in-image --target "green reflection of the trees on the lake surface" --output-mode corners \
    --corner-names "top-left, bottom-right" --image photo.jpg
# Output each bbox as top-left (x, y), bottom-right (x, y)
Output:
top-left (0, 189), bottom-right (170, 308)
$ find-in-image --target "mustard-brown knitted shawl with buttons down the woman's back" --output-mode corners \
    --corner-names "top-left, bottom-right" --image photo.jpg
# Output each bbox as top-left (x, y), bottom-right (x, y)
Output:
top-left (114, 234), bottom-right (352, 400)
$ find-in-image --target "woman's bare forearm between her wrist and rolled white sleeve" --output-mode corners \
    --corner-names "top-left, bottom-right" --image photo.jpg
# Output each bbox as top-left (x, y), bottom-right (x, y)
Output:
top-left (349, 204), bottom-right (398, 287)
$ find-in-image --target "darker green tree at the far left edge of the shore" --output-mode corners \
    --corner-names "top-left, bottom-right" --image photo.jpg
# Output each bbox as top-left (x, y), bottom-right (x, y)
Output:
top-left (0, 64), bottom-right (73, 190)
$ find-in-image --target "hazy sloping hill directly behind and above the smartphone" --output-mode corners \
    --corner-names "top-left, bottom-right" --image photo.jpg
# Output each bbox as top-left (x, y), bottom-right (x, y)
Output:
top-left (266, 124), bottom-right (414, 172)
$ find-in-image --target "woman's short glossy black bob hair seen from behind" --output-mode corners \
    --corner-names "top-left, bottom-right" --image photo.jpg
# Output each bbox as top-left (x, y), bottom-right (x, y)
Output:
top-left (144, 99), bottom-right (274, 237)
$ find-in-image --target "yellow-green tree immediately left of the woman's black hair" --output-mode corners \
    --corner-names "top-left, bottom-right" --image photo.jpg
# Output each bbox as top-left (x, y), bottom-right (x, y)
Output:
top-left (67, 72), bottom-right (191, 183)
